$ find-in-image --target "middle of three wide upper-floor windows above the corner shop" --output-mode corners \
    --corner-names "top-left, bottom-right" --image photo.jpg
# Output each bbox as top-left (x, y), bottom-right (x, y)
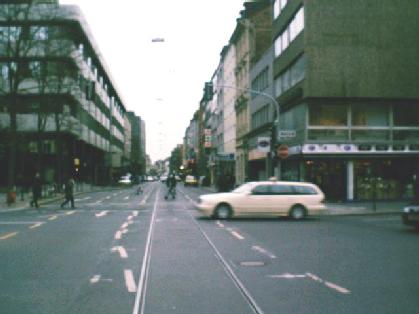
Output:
top-left (352, 104), bottom-right (389, 126)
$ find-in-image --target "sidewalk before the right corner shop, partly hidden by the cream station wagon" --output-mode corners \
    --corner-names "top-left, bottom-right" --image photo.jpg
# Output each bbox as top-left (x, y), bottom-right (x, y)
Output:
top-left (200, 186), bottom-right (410, 215)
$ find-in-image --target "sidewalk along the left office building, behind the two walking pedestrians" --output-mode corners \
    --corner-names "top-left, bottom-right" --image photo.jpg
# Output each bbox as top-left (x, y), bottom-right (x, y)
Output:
top-left (0, 184), bottom-right (119, 213)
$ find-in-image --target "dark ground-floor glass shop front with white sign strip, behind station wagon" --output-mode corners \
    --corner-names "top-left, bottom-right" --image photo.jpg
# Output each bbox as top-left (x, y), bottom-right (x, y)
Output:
top-left (281, 145), bottom-right (419, 201)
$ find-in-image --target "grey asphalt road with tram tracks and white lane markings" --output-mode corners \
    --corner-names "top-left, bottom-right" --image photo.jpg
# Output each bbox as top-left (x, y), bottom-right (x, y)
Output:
top-left (0, 182), bottom-right (419, 314)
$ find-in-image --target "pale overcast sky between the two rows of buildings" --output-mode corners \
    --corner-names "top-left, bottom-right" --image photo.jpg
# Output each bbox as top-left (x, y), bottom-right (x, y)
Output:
top-left (60, 0), bottom-right (244, 162)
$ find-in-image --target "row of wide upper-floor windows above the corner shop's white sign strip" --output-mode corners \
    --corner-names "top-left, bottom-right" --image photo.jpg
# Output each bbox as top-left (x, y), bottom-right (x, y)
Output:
top-left (309, 104), bottom-right (419, 127)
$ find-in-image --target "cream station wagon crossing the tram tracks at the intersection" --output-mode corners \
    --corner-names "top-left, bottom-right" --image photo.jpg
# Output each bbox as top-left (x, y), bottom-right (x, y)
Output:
top-left (197, 181), bottom-right (325, 219)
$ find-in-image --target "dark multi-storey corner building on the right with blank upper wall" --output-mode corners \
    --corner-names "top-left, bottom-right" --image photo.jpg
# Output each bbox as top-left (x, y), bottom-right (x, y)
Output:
top-left (273, 0), bottom-right (419, 200)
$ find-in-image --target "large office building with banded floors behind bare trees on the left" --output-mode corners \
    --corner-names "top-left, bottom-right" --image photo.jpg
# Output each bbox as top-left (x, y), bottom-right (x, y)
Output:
top-left (0, 1), bottom-right (125, 186)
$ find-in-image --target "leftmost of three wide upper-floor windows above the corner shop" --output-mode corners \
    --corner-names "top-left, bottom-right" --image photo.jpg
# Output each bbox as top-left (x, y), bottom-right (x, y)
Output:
top-left (309, 105), bottom-right (348, 126)
